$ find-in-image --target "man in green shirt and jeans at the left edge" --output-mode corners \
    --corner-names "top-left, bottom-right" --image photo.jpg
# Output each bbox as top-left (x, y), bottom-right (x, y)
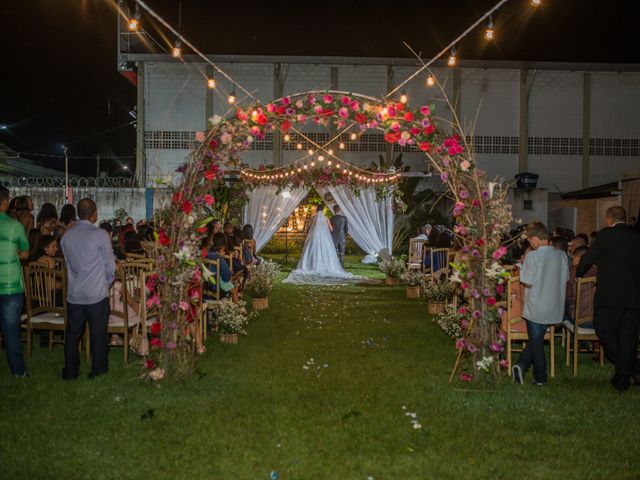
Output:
top-left (0, 187), bottom-right (29, 377)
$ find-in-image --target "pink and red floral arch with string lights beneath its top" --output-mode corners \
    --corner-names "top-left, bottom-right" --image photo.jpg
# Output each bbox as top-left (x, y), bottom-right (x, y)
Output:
top-left (145, 91), bottom-right (511, 380)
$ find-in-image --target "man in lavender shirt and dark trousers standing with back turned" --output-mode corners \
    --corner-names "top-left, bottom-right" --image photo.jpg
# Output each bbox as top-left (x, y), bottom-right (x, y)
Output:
top-left (62, 198), bottom-right (116, 380)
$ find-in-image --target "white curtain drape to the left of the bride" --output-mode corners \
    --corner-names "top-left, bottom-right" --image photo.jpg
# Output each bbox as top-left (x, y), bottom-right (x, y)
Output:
top-left (244, 185), bottom-right (308, 251)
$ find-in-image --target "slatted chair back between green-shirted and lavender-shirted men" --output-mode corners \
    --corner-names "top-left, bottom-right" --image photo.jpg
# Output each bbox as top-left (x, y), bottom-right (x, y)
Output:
top-left (24, 262), bottom-right (67, 318)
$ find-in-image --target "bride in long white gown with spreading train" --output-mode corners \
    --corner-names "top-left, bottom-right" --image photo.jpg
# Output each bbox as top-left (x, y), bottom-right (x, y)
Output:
top-left (283, 206), bottom-right (361, 285)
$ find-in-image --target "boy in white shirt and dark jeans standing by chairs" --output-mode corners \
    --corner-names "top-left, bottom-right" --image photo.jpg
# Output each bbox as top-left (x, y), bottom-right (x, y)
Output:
top-left (512, 222), bottom-right (569, 385)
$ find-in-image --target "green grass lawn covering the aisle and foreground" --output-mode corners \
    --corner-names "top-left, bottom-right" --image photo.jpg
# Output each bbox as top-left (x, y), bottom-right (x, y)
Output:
top-left (0, 256), bottom-right (640, 480)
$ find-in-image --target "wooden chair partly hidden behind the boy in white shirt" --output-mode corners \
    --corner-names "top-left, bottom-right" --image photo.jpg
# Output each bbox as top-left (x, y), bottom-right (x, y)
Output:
top-left (502, 276), bottom-right (556, 377)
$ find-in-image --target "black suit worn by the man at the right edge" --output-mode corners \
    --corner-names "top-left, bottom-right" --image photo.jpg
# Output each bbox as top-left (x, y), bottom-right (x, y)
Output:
top-left (576, 223), bottom-right (640, 390)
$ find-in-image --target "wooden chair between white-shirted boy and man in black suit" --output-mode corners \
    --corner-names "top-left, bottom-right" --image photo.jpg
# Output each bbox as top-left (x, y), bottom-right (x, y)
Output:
top-left (562, 277), bottom-right (604, 377)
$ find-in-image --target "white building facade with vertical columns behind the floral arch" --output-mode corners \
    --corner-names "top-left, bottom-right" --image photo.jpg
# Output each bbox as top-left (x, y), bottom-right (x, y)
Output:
top-left (128, 54), bottom-right (640, 197)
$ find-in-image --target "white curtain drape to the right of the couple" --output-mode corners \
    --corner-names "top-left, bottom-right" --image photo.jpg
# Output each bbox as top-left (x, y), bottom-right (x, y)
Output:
top-left (320, 185), bottom-right (393, 263)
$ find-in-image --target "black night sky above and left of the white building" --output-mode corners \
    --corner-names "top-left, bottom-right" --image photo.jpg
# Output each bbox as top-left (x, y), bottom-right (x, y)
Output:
top-left (0, 0), bottom-right (640, 174)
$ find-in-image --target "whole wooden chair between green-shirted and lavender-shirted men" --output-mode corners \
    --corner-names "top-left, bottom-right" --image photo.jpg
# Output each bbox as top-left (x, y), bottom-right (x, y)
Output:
top-left (24, 263), bottom-right (67, 357)
